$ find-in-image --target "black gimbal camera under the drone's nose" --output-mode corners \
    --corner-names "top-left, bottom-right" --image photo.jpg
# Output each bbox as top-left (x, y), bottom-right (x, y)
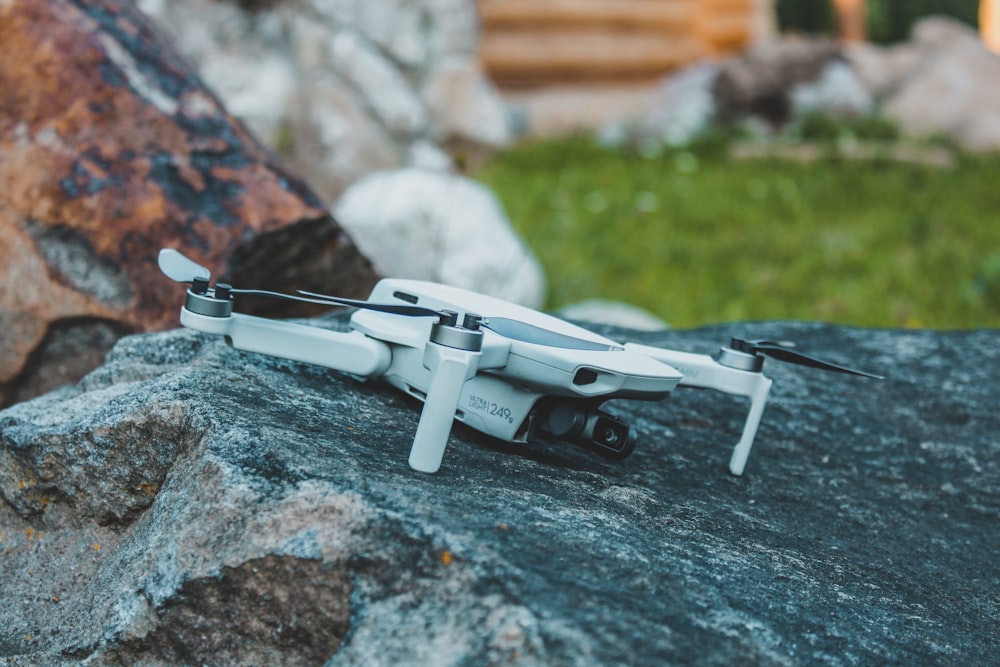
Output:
top-left (537, 401), bottom-right (635, 459)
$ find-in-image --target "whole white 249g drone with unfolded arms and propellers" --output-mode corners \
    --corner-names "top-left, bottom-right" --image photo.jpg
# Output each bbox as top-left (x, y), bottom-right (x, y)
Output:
top-left (159, 249), bottom-right (879, 475)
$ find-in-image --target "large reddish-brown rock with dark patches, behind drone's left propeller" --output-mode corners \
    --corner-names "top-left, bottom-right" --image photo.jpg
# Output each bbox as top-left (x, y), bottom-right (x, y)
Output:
top-left (0, 0), bottom-right (375, 404)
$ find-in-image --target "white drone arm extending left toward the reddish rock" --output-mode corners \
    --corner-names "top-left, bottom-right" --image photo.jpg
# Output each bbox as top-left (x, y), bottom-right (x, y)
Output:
top-left (181, 308), bottom-right (392, 377)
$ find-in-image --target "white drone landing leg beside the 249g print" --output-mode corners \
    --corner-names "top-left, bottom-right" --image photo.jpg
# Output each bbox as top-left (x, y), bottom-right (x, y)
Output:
top-left (410, 342), bottom-right (482, 473)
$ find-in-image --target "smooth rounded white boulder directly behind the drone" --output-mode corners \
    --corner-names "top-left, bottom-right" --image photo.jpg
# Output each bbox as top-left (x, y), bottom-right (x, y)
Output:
top-left (333, 168), bottom-right (545, 308)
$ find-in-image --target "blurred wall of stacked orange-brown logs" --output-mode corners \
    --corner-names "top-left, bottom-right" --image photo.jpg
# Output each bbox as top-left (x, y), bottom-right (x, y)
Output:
top-left (479, 0), bottom-right (769, 88)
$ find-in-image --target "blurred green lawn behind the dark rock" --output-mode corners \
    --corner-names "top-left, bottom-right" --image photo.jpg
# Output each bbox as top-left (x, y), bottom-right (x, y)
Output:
top-left (476, 138), bottom-right (1000, 329)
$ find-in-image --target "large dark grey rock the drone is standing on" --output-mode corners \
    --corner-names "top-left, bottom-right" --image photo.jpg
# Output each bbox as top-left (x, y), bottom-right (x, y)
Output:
top-left (0, 318), bottom-right (1000, 666)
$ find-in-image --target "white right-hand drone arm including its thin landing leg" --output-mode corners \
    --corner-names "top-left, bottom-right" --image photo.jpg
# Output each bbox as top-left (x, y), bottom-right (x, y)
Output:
top-left (625, 343), bottom-right (772, 476)
